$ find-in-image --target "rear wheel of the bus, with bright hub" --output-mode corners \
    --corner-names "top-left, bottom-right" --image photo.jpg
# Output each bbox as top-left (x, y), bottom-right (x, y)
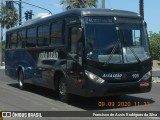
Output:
top-left (18, 70), bottom-right (25, 90)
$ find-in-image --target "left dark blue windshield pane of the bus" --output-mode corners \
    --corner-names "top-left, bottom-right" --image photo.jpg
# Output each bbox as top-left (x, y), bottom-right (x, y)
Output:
top-left (86, 24), bottom-right (116, 54)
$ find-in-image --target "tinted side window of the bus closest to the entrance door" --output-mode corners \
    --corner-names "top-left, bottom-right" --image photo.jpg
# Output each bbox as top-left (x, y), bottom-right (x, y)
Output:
top-left (51, 22), bottom-right (63, 46)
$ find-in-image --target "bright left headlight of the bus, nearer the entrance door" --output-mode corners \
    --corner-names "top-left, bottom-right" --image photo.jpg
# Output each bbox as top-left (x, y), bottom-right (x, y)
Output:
top-left (85, 70), bottom-right (105, 83)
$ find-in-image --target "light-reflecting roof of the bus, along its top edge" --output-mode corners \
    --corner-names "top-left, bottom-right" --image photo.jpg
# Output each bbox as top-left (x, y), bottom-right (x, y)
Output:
top-left (8, 8), bottom-right (141, 31)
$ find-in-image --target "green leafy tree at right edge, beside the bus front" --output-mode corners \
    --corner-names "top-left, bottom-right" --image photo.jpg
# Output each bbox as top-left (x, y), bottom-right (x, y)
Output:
top-left (149, 32), bottom-right (160, 60)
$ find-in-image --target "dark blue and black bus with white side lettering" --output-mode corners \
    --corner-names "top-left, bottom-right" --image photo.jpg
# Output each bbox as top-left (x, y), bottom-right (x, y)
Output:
top-left (5, 8), bottom-right (152, 102)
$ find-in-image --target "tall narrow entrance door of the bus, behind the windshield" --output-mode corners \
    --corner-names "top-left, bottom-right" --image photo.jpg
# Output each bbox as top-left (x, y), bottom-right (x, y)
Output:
top-left (67, 27), bottom-right (83, 89)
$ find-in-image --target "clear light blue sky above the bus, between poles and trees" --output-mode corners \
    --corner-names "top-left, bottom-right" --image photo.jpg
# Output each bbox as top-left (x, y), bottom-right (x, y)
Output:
top-left (10, 0), bottom-right (160, 33)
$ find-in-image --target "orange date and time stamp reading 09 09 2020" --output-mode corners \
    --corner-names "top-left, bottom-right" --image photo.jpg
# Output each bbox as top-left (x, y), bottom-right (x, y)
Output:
top-left (97, 101), bottom-right (151, 107)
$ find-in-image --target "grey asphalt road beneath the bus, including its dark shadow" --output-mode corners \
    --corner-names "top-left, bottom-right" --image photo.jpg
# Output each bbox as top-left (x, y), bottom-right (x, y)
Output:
top-left (0, 68), bottom-right (160, 120)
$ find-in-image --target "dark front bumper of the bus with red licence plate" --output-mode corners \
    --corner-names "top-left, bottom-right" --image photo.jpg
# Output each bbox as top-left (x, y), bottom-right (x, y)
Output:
top-left (82, 78), bottom-right (152, 97)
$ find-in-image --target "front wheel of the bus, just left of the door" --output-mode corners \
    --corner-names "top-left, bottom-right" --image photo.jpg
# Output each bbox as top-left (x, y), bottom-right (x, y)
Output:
top-left (58, 77), bottom-right (70, 103)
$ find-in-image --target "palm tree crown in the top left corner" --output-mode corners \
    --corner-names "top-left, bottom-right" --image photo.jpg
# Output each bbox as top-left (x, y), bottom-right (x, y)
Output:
top-left (0, 5), bottom-right (18, 28)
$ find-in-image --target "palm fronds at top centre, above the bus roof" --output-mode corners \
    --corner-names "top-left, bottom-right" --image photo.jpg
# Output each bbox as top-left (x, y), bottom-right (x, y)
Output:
top-left (61, 0), bottom-right (98, 10)
